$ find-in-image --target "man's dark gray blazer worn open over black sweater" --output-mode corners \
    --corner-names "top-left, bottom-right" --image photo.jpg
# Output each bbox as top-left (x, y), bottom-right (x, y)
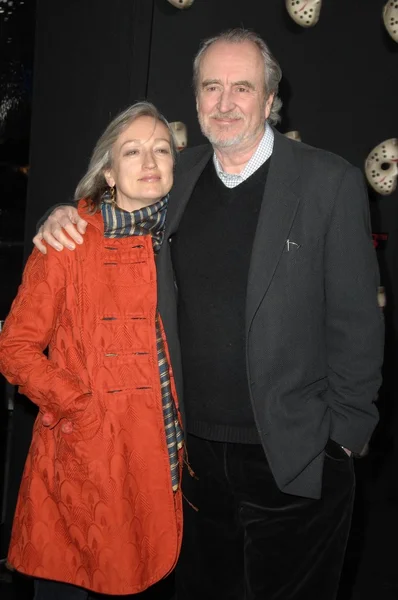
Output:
top-left (158, 132), bottom-right (384, 498)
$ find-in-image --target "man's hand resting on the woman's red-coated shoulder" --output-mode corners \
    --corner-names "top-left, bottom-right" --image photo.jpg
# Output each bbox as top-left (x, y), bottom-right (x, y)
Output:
top-left (33, 205), bottom-right (87, 254)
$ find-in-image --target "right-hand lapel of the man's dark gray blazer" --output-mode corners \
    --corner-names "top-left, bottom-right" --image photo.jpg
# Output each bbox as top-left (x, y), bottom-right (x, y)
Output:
top-left (246, 131), bottom-right (299, 331)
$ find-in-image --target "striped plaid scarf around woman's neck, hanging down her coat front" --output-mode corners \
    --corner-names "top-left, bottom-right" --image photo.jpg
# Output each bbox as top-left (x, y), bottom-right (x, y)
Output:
top-left (101, 196), bottom-right (184, 491)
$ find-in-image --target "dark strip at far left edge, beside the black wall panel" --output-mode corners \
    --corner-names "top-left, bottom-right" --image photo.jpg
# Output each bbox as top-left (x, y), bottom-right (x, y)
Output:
top-left (0, 0), bottom-right (35, 319)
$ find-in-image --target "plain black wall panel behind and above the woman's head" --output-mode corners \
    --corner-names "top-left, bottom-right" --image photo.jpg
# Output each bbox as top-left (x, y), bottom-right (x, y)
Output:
top-left (25, 0), bottom-right (153, 246)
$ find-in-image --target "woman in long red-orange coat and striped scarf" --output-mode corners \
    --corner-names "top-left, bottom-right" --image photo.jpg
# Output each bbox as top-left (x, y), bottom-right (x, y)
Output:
top-left (0, 103), bottom-right (183, 600)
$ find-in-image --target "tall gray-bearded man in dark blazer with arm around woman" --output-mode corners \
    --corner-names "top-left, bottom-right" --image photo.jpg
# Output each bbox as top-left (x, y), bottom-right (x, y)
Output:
top-left (35, 29), bottom-right (383, 600)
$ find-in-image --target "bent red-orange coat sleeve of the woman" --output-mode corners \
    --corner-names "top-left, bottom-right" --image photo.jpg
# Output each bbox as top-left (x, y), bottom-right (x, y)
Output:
top-left (0, 249), bottom-right (90, 420)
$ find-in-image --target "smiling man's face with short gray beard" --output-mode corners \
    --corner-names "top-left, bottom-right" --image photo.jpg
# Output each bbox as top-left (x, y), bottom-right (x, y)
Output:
top-left (196, 41), bottom-right (273, 149)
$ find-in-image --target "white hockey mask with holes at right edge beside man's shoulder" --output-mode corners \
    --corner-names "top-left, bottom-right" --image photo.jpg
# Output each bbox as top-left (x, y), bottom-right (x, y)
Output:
top-left (365, 138), bottom-right (398, 196)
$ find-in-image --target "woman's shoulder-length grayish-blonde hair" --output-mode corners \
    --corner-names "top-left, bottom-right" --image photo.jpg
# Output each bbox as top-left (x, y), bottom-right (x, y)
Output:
top-left (74, 102), bottom-right (177, 212)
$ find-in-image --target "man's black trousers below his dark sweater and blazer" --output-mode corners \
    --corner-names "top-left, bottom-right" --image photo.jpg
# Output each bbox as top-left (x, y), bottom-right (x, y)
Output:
top-left (176, 435), bottom-right (355, 600)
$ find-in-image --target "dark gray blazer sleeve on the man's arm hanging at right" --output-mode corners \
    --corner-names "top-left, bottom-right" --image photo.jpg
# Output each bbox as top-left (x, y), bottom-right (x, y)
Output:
top-left (325, 167), bottom-right (384, 452)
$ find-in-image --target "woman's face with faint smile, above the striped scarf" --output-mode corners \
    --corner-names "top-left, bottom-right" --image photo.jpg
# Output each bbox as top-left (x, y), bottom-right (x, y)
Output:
top-left (105, 117), bottom-right (173, 211)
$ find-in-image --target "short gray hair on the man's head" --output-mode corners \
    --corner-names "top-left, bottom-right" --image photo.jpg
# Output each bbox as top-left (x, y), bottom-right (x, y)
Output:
top-left (193, 28), bottom-right (282, 125)
